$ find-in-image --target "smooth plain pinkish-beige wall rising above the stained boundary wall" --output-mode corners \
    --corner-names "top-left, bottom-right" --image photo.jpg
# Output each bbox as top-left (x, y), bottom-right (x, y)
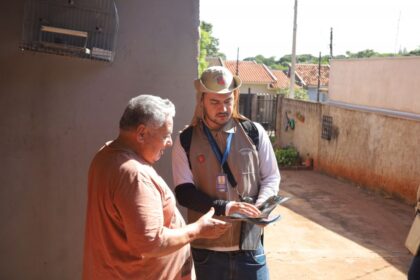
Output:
top-left (329, 57), bottom-right (420, 114)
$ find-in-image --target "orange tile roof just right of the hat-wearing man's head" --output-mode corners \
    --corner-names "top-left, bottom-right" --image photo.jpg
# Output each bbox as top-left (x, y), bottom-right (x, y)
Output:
top-left (224, 60), bottom-right (277, 84)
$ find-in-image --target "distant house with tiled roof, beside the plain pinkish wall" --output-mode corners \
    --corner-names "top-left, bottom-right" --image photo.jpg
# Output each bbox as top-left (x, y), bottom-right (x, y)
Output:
top-left (289, 64), bottom-right (330, 102)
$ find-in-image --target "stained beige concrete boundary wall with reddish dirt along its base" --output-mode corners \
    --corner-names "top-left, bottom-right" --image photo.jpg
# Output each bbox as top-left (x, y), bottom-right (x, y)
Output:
top-left (276, 98), bottom-right (420, 203)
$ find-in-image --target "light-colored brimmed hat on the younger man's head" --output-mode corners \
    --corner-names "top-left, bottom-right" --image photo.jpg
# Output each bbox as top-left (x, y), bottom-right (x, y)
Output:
top-left (194, 66), bottom-right (242, 94)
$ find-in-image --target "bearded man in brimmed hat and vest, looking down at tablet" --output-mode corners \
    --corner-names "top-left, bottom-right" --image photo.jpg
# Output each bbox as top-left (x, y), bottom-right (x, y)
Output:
top-left (172, 66), bottom-right (280, 280)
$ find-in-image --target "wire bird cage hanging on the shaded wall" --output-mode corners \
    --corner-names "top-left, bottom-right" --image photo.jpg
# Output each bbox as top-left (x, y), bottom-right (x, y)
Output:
top-left (20, 0), bottom-right (118, 61)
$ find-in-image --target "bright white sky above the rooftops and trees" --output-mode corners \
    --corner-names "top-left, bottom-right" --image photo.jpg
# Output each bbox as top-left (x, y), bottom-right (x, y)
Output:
top-left (200, 0), bottom-right (420, 60)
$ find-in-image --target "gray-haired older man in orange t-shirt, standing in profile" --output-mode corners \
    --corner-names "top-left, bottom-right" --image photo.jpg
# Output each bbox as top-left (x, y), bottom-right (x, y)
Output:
top-left (83, 95), bottom-right (230, 280)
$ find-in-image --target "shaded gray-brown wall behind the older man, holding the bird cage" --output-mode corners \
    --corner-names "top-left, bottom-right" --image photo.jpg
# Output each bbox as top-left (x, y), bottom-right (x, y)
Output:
top-left (0, 0), bottom-right (199, 279)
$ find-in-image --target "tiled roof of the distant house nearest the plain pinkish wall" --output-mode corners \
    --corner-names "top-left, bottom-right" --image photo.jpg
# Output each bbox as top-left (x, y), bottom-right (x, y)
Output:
top-left (295, 64), bottom-right (330, 86)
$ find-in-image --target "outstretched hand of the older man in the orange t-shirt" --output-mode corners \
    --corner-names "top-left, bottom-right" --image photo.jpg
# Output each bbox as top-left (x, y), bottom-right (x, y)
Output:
top-left (195, 207), bottom-right (232, 239)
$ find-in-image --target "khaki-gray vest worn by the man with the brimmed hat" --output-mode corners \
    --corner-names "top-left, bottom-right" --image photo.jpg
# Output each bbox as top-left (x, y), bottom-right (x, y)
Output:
top-left (188, 119), bottom-right (261, 250)
